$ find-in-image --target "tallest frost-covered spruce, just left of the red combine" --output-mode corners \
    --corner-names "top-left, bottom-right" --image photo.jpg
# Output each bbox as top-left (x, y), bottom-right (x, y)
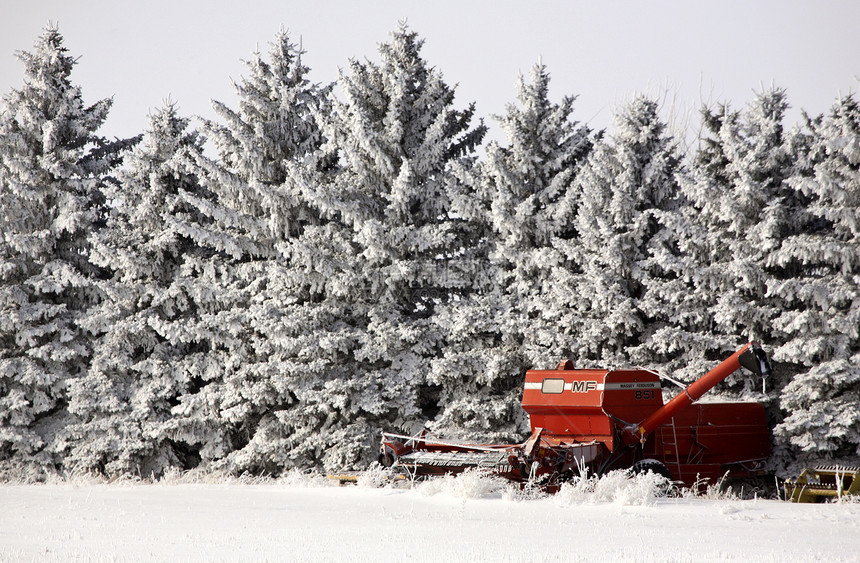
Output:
top-left (308, 24), bottom-right (485, 466)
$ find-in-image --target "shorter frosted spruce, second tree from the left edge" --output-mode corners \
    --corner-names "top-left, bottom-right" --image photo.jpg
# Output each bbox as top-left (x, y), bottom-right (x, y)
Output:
top-left (64, 102), bottom-right (211, 477)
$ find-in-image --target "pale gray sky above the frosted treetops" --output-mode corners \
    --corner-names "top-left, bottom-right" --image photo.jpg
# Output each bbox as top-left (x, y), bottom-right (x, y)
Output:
top-left (0, 0), bottom-right (860, 145)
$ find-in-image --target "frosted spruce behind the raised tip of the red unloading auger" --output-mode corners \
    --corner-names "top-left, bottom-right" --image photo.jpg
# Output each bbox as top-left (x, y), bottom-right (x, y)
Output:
top-left (677, 89), bottom-right (804, 391)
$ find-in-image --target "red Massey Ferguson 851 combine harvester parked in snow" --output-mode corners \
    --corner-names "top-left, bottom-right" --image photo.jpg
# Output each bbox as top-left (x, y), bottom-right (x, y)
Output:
top-left (380, 342), bottom-right (771, 487)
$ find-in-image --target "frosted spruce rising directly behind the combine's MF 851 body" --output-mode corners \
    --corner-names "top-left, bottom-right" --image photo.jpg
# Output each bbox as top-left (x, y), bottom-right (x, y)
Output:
top-left (572, 97), bottom-right (679, 367)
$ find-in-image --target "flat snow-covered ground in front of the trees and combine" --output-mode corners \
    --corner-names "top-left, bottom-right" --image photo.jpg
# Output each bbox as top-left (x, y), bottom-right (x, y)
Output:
top-left (0, 476), bottom-right (860, 563)
